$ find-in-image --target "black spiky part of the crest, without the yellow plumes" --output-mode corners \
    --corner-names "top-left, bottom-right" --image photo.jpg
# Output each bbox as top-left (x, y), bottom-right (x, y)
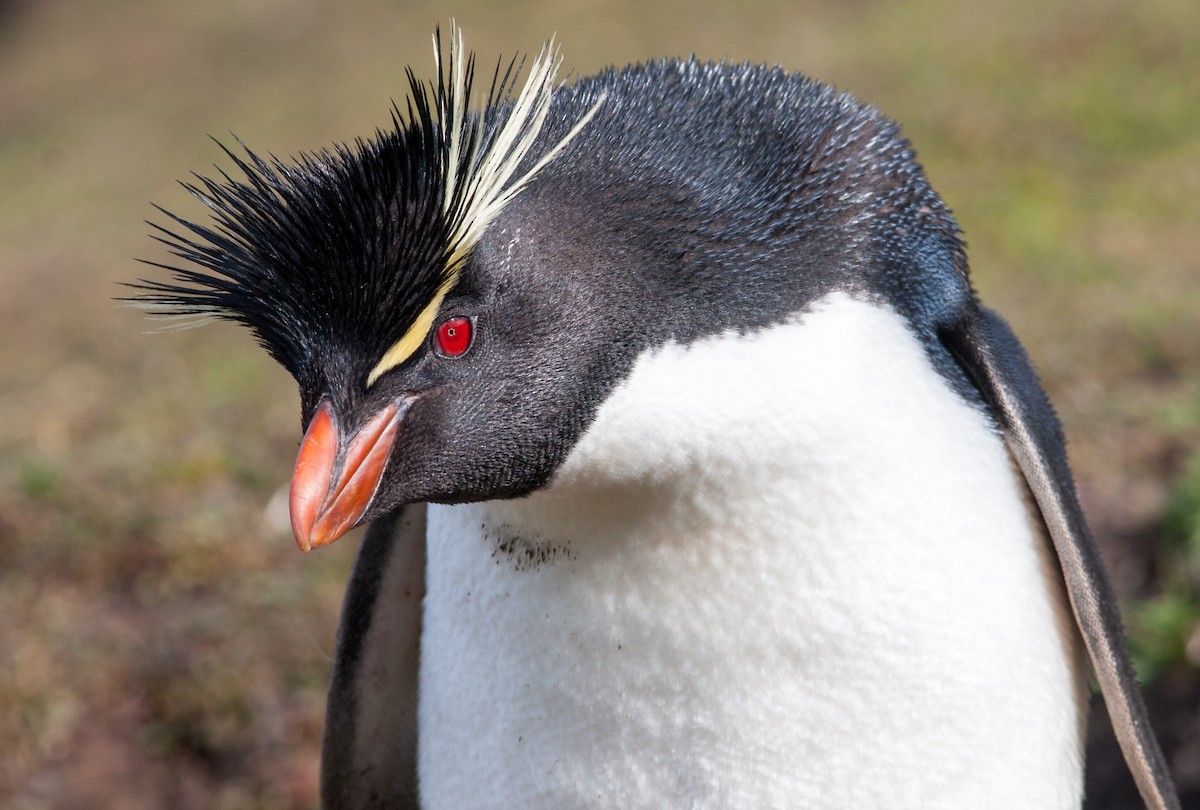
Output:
top-left (138, 116), bottom-right (450, 388)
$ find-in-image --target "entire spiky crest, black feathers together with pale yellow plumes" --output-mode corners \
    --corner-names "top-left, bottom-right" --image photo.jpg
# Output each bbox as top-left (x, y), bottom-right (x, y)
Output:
top-left (132, 26), bottom-right (599, 400)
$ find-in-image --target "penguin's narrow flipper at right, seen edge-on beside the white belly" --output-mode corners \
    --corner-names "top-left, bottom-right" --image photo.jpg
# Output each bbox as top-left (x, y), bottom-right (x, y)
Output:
top-left (940, 305), bottom-right (1180, 810)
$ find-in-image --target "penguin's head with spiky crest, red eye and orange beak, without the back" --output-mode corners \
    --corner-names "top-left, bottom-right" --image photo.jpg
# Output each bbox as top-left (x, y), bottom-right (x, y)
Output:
top-left (138, 30), bottom-right (616, 550)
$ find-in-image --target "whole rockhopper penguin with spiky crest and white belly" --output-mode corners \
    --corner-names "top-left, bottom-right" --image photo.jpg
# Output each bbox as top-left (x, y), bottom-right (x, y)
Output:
top-left (134, 29), bottom-right (1180, 810)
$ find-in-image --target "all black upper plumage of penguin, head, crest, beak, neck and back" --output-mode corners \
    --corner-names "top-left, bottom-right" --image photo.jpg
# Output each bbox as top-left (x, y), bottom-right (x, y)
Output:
top-left (139, 31), bottom-right (971, 550)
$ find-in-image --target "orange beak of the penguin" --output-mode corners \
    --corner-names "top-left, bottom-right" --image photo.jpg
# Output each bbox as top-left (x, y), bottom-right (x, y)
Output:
top-left (289, 402), bottom-right (407, 551)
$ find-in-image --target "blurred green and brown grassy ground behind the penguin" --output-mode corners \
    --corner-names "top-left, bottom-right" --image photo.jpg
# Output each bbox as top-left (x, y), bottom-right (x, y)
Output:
top-left (0, 0), bottom-right (1200, 810)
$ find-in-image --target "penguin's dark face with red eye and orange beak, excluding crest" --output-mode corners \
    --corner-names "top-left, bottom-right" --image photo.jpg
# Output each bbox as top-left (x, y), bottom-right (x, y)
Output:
top-left (283, 194), bottom-right (641, 547)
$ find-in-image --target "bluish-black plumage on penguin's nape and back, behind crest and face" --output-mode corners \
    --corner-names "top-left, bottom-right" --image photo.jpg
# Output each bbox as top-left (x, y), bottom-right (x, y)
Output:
top-left (521, 59), bottom-right (977, 388)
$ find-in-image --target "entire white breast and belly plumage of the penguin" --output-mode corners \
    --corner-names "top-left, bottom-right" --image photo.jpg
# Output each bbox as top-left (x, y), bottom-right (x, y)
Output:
top-left (419, 295), bottom-right (1086, 810)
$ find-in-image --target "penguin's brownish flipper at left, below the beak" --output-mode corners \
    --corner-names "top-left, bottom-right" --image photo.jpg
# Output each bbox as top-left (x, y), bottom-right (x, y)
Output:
top-left (320, 504), bottom-right (426, 810)
